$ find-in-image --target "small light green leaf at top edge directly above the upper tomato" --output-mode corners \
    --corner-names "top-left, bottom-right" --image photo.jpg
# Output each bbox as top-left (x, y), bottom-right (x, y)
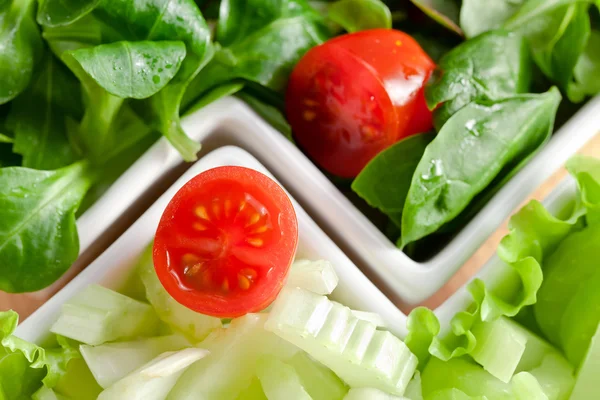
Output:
top-left (327, 0), bottom-right (392, 32)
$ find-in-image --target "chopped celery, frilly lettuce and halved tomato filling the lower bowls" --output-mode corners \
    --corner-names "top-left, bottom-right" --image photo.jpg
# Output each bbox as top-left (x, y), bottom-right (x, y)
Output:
top-left (0, 153), bottom-right (600, 400)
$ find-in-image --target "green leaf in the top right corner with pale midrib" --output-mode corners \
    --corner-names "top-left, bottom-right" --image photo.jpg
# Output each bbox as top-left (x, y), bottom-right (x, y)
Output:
top-left (510, 2), bottom-right (591, 89)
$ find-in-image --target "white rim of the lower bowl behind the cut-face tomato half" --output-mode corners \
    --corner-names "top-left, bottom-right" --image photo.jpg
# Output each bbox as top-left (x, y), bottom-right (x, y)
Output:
top-left (15, 146), bottom-right (406, 343)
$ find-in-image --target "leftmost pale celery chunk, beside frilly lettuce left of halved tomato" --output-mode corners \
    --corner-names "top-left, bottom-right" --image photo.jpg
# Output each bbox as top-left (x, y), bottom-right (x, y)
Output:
top-left (50, 285), bottom-right (159, 345)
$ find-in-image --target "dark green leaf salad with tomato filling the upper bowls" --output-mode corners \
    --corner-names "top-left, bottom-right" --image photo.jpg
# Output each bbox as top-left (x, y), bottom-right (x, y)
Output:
top-left (0, 0), bottom-right (600, 292)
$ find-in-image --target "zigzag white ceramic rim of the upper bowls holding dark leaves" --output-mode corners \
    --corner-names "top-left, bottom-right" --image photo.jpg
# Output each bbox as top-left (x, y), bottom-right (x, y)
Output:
top-left (74, 97), bottom-right (600, 305)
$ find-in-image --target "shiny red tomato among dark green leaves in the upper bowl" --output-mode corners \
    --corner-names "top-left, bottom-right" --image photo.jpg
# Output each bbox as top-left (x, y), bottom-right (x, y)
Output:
top-left (286, 29), bottom-right (435, 178)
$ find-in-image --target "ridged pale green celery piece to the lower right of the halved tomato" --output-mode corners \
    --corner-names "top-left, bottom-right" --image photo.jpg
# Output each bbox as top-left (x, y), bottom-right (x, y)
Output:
top-left (265, 288), bottom-right (418, 395)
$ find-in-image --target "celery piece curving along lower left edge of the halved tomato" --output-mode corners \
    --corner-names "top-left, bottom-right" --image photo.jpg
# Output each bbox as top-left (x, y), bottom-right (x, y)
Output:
top-left (138, 245), bottom-right (222, 342)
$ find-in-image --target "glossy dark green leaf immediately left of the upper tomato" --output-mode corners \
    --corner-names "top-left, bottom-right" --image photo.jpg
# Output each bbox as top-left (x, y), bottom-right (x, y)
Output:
top-left (184, 16), bottom-right (328, 109)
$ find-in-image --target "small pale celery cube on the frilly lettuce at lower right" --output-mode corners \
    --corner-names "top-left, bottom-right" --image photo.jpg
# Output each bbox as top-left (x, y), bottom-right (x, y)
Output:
top-left (471, 317), bottom-right (527, 382)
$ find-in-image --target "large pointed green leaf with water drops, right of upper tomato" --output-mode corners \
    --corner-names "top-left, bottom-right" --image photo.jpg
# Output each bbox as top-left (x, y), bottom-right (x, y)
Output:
top-left (401, 88), bottom-right (560, 247)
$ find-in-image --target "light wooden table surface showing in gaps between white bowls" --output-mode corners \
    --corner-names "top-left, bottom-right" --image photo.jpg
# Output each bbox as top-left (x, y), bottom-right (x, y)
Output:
top-left (0, 134), bottom-right (600, 320)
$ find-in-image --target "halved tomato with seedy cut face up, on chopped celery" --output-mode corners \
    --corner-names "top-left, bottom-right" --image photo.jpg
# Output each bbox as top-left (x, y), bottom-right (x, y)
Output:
top-left (154, 166), bottom-right (298, 318)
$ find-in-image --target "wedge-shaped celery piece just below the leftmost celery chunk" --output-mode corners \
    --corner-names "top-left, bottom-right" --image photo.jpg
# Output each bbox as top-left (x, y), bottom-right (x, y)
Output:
top-left (79, 335), bottom-right (191, 389)
